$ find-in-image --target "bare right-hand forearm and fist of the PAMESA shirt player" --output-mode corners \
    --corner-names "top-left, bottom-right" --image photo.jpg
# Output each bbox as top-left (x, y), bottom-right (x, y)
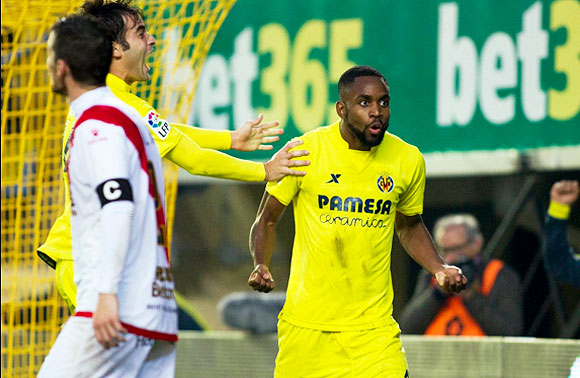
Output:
top-left (395, 213), bottom-right (467, 293)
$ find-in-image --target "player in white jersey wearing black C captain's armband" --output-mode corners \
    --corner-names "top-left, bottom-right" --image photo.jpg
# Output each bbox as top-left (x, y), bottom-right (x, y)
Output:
top-left (38, 15), bottom-right (177, 377)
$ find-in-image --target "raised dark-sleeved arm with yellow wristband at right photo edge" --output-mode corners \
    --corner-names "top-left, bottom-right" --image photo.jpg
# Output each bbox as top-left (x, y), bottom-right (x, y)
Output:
top-left (543, 181), bottom-right (580, 288)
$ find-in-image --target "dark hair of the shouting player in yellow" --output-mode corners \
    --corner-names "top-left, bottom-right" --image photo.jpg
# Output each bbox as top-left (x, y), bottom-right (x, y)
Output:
top-left (79, 0), bottom-right (145, 50)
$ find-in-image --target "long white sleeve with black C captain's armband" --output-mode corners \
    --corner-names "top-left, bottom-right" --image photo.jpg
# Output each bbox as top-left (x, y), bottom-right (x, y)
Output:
top-left (75, 120), bottom-right (138, 294)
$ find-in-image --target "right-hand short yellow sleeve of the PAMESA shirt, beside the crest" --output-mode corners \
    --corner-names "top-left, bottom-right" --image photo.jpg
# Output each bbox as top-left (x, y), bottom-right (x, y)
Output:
top-left (397, 148), bottom-right (425, 216)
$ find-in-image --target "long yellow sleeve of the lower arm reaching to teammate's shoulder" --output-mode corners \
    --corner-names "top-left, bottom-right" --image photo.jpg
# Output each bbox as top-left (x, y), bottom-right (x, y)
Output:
top-left (165, 128), bottom-right (266, 181)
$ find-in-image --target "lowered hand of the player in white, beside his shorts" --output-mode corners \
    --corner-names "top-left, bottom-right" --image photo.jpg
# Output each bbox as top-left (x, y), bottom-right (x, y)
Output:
top-left (93, 293), bottom-right (127, 349)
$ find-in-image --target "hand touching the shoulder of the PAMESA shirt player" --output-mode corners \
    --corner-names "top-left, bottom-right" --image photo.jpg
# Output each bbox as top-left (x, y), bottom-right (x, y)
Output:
top-left (264, 140), bottom-right (310, 181)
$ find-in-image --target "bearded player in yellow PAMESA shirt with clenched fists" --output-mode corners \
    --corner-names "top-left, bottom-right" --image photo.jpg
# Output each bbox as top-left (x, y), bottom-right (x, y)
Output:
top-left (248, 66), bottom-right (467, 378)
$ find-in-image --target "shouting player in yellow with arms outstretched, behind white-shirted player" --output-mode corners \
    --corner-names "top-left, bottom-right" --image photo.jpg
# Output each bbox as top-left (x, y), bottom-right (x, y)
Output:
top-left (38, 0), bottom-right (308, 312)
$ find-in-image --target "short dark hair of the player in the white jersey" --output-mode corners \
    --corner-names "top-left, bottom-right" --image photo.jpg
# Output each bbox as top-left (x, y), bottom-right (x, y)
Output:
top-left (51, 14), bottom-right (113, 85)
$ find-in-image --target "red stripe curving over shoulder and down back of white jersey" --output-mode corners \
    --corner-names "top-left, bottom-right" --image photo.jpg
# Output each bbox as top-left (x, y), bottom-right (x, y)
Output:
top-left (72, 105), bottom-right (171, 266)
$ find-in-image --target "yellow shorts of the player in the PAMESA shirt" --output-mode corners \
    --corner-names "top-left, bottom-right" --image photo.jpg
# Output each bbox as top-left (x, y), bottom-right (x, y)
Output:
top-left (274, 320), bottom-right (409, 378)
